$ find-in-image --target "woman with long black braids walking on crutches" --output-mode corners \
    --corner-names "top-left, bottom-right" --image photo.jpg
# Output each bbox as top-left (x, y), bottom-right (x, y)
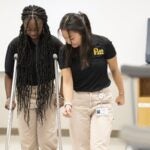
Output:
top-left (5, 5), bottom-right (62, 150)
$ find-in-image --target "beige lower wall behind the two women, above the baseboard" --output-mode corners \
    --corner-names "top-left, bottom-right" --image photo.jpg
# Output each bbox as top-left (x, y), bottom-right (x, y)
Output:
top-left (0, 72), bottom-right (137, 130)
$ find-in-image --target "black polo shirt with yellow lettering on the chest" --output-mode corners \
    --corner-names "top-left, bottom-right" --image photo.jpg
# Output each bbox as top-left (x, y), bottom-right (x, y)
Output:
top-left (59, 35), bottom-right (116, 92)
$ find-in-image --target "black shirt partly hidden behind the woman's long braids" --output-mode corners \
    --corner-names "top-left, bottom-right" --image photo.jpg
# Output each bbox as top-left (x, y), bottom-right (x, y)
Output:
top-left (5, 35), bottom-right (62, 85)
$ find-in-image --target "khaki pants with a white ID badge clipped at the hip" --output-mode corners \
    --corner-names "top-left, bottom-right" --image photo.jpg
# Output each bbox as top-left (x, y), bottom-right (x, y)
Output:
top-left (70, 88), bottom-right (113, 150)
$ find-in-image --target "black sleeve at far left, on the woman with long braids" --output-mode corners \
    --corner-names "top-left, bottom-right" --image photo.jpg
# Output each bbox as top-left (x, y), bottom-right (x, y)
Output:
top-left (5, 38), bottom-right (17, 78)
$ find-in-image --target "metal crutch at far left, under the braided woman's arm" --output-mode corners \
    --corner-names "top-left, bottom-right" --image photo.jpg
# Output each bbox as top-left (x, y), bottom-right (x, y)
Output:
top-left (5, 54), bottom-right (18, 150)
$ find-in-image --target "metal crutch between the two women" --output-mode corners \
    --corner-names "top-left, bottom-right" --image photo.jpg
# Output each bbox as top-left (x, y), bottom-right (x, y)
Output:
top-left (53, 54), bottom-right (63, 150)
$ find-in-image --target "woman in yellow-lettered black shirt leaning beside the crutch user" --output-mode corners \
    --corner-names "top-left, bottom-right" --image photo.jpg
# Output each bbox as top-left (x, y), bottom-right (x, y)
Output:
top-left (59, 13), bottom-right (125, 150)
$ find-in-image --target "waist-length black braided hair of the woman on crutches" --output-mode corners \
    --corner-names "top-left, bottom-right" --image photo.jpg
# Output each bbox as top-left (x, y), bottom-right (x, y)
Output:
top-left (17, 5), bottom-right (54, 123)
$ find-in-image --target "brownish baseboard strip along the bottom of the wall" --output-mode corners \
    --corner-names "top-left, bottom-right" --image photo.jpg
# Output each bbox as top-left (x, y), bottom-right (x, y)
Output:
top-left (0, 128), bottom-right (119, 138)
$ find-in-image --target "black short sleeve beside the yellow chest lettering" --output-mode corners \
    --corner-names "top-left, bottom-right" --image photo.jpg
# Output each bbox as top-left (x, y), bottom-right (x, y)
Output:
top-left (105, 41), bottom-right (116, 59)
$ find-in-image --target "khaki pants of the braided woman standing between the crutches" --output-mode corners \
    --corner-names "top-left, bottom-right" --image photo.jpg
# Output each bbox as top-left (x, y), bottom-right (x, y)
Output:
top-left (18, 86), bottom-right (57, 150)
